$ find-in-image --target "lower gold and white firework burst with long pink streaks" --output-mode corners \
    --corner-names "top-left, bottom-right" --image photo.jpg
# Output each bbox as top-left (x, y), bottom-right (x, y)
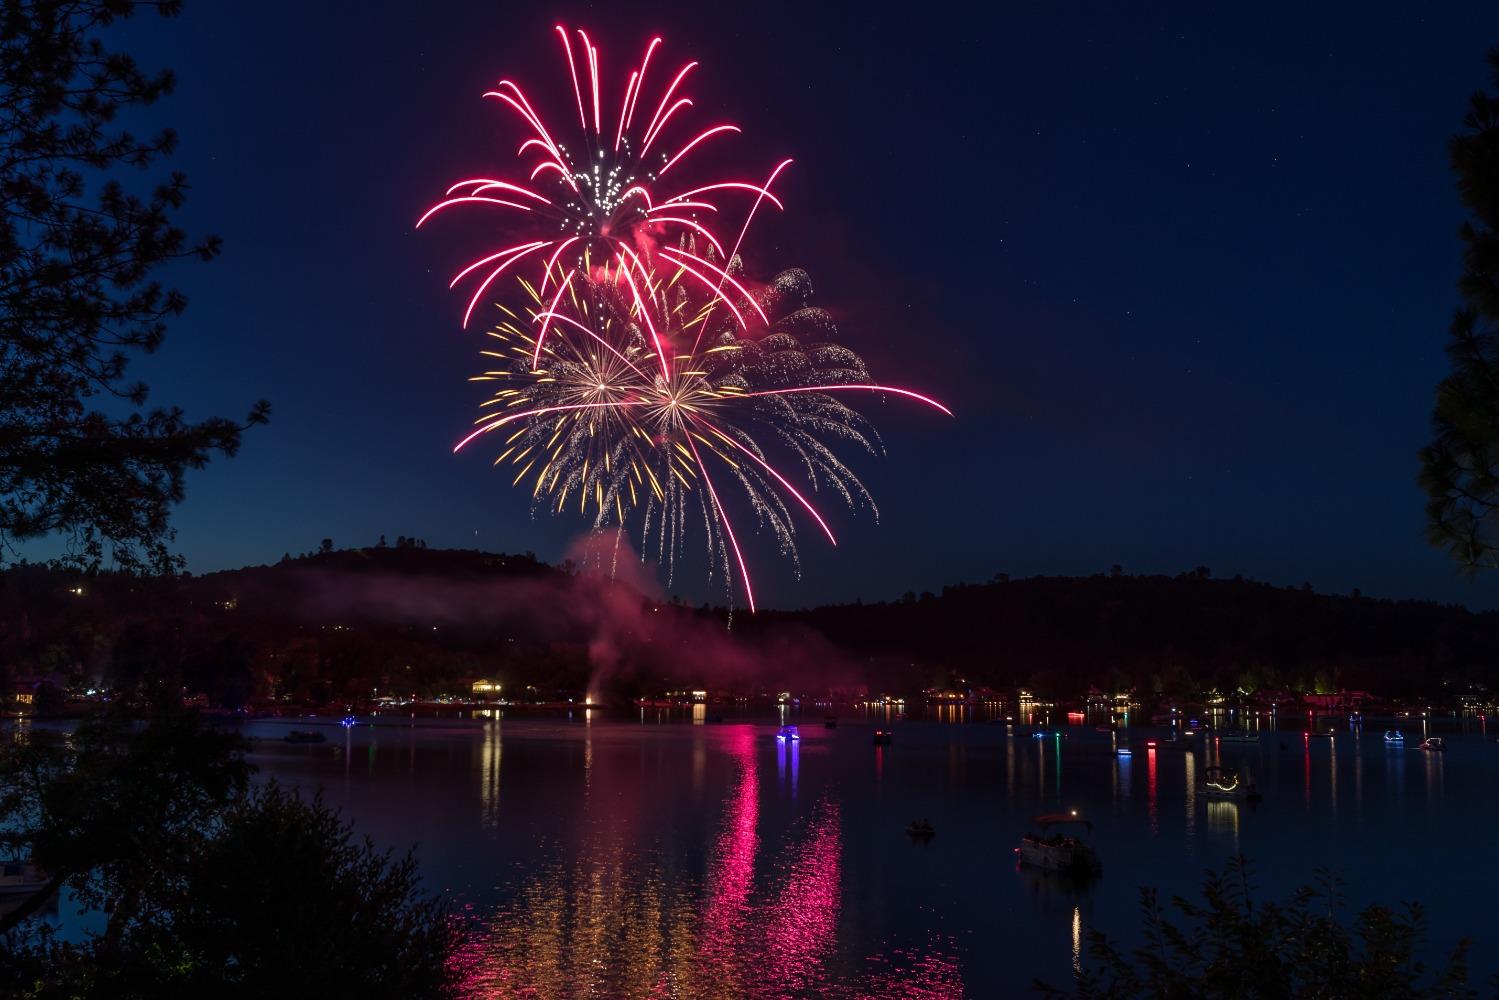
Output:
top-left (454, 260), bottom-right (947, 610)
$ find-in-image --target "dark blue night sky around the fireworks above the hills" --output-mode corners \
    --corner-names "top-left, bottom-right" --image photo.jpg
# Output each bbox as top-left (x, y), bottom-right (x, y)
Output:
top-left (102, 0), bottom-right (1499, 607)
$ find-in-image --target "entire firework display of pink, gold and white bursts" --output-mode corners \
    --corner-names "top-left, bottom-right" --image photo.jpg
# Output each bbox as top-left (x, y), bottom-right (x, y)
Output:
top-left (417, 27), bottom-right (949, 612)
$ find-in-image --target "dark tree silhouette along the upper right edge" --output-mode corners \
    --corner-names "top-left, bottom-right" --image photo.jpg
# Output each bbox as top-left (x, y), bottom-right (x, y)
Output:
top-left (1420, 46), bottom-right (1499, 573)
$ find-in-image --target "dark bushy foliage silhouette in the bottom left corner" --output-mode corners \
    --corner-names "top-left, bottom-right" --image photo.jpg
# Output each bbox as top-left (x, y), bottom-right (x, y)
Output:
top-left (0, 701), bottom-right (459, 1000)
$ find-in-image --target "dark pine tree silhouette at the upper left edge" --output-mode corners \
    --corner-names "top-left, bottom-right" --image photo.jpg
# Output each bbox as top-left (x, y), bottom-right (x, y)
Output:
top-left (0, 0), bottom-right (270, 570)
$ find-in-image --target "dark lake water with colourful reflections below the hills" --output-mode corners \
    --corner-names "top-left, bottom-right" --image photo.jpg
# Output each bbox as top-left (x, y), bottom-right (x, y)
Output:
top-left (23, 714), bottom-right (1499, 997)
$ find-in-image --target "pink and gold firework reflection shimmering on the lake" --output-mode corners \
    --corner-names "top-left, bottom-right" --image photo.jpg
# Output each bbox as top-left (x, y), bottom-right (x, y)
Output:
top-left (454, 727), bottom-right (959, 1000)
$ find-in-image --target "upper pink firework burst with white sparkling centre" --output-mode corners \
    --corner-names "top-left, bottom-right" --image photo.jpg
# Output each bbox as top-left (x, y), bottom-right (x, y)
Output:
top-left (417, 25), bottom-right (791, 327)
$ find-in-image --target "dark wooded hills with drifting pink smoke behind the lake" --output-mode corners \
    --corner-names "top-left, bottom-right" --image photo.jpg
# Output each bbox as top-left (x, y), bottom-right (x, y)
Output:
top-left (0, 551), bottom-right (1499, 708)
